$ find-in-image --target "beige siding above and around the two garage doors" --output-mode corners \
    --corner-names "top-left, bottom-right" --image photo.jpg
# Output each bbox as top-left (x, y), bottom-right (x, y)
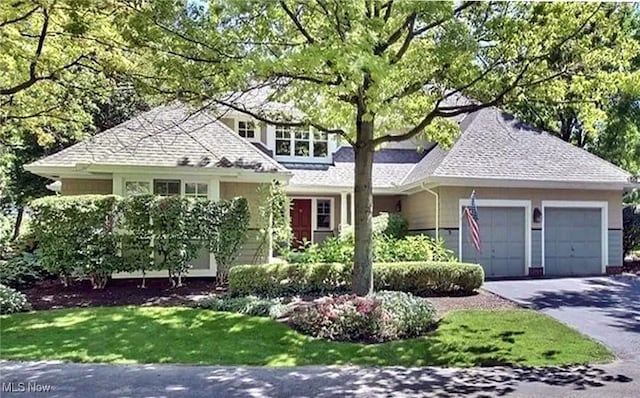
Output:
top-left (438, 187), bottom-right (622, 228)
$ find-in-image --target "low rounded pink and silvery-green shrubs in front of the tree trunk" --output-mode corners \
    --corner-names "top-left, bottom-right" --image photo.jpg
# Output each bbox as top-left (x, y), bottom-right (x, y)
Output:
top-left (289, 292), bottom-right (435, 342)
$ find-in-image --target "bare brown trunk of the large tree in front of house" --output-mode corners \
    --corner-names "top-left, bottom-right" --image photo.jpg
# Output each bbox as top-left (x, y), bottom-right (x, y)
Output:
top-left (352, 122), bottom-right (374, 296)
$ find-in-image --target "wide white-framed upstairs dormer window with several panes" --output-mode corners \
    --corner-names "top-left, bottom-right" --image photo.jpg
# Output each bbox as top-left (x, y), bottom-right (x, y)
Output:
top-left (275, 126), bottom-right (329, 159)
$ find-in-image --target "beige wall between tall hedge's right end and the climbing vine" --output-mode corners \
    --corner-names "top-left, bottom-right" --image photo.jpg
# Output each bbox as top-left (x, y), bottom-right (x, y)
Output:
top-left (220, 181), bottom-right (267, 264)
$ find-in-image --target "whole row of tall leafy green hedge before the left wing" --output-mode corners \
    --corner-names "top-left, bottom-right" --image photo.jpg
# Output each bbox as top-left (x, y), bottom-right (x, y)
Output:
top-left (31, 195), bottom-right (249, 289)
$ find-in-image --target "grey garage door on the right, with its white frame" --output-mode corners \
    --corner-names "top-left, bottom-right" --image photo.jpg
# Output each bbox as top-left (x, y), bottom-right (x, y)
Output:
top-left (542, 202), bottom-right (607, 276)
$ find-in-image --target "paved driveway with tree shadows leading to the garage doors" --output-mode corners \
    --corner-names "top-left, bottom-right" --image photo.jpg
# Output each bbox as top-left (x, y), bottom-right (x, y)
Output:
top-left (484, 275), bottom-right (640, 360)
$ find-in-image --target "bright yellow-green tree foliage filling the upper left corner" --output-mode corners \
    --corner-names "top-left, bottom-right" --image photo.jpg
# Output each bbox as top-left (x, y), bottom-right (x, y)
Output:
top-left (0, 0), bottom-right (135, 145)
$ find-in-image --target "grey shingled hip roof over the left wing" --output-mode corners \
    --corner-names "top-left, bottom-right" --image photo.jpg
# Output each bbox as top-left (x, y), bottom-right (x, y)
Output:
top-left (27, 104), bottom-right (286, 172)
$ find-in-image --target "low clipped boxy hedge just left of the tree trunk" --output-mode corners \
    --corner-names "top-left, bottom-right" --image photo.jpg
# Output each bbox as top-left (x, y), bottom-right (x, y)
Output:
top-left (229, 263), bottom-right (351, 297)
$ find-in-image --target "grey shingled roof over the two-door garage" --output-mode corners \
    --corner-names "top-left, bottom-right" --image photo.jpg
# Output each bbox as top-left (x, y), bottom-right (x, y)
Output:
top-left (403, 108), bottom-right (631, 184)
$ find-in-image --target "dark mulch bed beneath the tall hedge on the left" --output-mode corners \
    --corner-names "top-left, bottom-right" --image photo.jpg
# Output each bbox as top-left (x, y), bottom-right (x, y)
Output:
top-left (23, 278), bottom-right (222, 310)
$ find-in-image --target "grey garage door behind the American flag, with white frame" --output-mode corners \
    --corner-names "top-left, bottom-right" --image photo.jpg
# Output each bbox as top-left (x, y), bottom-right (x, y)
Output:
top-left (460, 200), bottom-right (530, 277)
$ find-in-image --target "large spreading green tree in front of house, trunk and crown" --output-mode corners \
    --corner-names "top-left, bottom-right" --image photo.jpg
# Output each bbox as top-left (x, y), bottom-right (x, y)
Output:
top-left (123, 0), bottom-right (637, 295)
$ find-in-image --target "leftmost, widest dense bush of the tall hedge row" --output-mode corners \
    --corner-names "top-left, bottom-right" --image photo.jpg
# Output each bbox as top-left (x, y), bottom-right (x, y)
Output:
top-left (31, 195), bottom-right (122, 288)
